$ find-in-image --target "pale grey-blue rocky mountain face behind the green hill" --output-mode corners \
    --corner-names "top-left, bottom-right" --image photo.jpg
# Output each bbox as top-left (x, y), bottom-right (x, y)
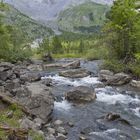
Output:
top-left (5, 0), bottom-right (113, 22)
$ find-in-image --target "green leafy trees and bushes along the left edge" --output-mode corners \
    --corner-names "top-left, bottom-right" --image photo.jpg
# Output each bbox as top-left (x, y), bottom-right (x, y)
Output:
top-left (0, 3), bottom-right (31, 62)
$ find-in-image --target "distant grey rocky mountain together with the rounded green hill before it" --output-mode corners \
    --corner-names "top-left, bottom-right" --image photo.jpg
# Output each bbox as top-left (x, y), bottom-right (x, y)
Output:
top-left (4, 0), bottom-right (113, 32)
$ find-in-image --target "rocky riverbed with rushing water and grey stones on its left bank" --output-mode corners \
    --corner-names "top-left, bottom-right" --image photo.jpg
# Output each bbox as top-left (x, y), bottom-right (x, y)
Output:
top-left (0, 59), bottom-right (140, 140)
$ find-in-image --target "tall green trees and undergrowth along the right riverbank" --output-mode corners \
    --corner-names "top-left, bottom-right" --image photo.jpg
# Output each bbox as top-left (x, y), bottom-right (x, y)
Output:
top-left (102, 0), bottom-right (140, 78)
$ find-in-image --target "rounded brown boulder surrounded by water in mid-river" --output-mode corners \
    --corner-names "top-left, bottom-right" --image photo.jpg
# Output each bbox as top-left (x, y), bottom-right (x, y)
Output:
top-left (65, 86), bottom-right (96, 103)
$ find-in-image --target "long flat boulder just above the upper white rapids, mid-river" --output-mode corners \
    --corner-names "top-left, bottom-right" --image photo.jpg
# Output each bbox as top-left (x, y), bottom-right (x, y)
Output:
top-left (59, 69), bottom-right (90, 78)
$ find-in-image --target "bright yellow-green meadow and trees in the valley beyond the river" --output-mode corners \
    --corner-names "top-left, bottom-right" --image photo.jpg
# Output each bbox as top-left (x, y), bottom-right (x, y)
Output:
top-left (38, 34), bottom-right (99, 57)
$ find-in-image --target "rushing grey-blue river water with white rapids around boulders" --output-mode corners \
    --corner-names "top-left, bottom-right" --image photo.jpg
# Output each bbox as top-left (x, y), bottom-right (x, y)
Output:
top-left (43, 62), bottom-right (140, 140)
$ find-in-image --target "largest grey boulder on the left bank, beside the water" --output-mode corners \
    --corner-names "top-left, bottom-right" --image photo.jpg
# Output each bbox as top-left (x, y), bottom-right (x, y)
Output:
top-left (24, 83), bottom-right (54, 123)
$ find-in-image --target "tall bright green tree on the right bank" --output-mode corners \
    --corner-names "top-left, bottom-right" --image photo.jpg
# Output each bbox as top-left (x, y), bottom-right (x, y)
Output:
top-left (104, 0), bottom-right (140, 63)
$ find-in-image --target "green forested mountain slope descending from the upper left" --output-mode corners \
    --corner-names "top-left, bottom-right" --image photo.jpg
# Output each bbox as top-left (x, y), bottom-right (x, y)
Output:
top-left (0, 4), bottom-right (53, 40)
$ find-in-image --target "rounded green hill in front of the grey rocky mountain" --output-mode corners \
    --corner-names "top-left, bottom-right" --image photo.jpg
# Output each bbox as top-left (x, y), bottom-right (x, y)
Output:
top-left (57, 2), bottom-right (110, 33)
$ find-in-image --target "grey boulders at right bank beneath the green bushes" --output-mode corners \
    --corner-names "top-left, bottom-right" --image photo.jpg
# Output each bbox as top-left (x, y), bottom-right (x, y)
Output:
top-left (99, 70), bottom-right (131, 86)
